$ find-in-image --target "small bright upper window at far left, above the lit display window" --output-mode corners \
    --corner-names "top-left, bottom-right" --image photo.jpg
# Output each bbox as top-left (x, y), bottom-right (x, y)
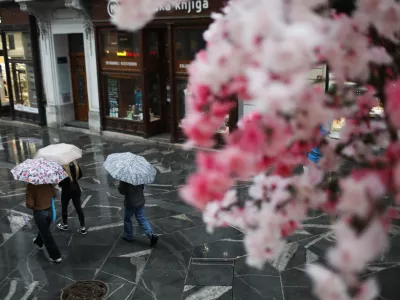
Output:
top-left (6, 31), bottom-right (32, 59)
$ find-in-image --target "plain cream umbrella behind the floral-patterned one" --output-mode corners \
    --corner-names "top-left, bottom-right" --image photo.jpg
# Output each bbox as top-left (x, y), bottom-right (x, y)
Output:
top-left (35, 144), bottom-right (82, 165)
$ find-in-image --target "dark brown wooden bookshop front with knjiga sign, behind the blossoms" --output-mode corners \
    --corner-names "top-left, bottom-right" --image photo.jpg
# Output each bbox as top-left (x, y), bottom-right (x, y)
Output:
top-left (92, 0), bottom-right (234, 141)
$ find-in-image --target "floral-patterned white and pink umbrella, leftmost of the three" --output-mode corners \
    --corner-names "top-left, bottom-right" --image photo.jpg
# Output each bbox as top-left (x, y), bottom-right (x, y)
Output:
top-left (11, 158), bottom-right (68, 185)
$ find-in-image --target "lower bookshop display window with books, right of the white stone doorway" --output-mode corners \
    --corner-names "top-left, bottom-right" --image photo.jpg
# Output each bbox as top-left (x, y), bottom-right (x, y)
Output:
top-left (106, 76), bottom-right (143, 122)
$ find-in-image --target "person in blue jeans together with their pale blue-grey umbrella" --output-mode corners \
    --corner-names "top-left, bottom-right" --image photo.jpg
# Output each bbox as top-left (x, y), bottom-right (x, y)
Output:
top-left (104, 153), bottom-right (158, 246)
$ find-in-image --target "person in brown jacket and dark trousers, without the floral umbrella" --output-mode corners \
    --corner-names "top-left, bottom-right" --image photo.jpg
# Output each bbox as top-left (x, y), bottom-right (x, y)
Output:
top-left (26, 183), bottom-right (62, 263)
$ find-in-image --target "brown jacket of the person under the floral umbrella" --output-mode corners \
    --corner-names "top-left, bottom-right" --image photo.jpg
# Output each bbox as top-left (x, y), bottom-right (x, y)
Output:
top-left (25, 183), bottom-right (56, 210)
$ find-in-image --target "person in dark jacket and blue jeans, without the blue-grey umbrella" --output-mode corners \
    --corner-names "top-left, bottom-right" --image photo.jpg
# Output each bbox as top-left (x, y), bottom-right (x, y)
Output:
top-left (118, 181), bottom-right (158, 246)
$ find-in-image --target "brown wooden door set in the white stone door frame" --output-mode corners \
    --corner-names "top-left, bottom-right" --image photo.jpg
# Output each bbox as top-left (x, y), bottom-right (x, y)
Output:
top-left (68, 33), bottom-right (89, 122)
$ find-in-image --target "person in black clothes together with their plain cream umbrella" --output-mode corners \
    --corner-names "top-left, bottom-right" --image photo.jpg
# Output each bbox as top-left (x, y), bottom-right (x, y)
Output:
top-left (35, 144), bottom-right (87, 235)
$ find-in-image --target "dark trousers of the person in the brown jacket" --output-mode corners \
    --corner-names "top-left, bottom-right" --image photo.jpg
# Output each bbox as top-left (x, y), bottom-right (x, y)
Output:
top-left (33, 208), bottom-right (61, 259)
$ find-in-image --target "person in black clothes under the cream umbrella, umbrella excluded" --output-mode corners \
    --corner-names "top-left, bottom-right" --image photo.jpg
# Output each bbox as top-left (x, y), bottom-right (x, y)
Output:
top-left (57, 161), bottom-right (87, 235)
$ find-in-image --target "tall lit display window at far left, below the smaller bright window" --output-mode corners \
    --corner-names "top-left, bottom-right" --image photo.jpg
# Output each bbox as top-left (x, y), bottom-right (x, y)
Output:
top-left (9, 62), bottom-right (38, 113)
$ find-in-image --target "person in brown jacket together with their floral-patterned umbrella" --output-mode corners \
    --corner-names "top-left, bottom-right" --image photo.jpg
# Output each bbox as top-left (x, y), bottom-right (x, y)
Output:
top-left (11, 158), bottom-right (67, 263)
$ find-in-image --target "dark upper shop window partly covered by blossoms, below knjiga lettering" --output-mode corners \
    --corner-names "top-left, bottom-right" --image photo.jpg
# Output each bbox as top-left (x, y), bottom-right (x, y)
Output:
top-left (176, 29), bottom-right (206, 61)
